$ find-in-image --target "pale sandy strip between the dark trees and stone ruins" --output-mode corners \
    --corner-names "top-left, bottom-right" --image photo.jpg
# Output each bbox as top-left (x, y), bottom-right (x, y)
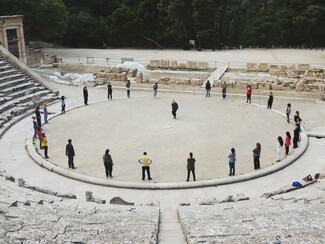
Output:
top-left (43, 48), bottom-right (325, 67)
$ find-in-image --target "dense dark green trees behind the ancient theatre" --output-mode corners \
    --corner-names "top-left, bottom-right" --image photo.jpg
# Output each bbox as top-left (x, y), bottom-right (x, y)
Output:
top-left (0, 0), bottom-right (325, 49)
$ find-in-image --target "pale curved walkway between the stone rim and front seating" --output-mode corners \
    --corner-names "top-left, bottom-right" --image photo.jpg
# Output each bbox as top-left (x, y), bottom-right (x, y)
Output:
top-left (0, 84), bottom-right (325, 206)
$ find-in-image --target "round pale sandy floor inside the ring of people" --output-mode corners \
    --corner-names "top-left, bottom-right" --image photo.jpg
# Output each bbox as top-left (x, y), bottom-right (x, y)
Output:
top-left (39, 87), bottom-right (293, 182)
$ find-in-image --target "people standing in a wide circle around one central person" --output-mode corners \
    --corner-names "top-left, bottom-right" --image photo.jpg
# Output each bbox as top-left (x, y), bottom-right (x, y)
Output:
top-left (32, 80), bottom-right (302, 181)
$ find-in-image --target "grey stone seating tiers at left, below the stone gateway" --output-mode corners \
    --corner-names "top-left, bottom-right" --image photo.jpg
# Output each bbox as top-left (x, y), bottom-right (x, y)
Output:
top-left (0, 47), bottom-right (59, 130)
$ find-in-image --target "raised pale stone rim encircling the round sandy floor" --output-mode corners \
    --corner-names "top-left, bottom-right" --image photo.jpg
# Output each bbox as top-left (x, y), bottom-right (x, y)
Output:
top-left (25, 100), bottom-right (309, 190)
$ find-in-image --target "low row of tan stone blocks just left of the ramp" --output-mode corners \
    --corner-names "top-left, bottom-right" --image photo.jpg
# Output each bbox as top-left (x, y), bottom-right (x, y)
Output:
top-left (147, 60), bottom-right (209, 71)
